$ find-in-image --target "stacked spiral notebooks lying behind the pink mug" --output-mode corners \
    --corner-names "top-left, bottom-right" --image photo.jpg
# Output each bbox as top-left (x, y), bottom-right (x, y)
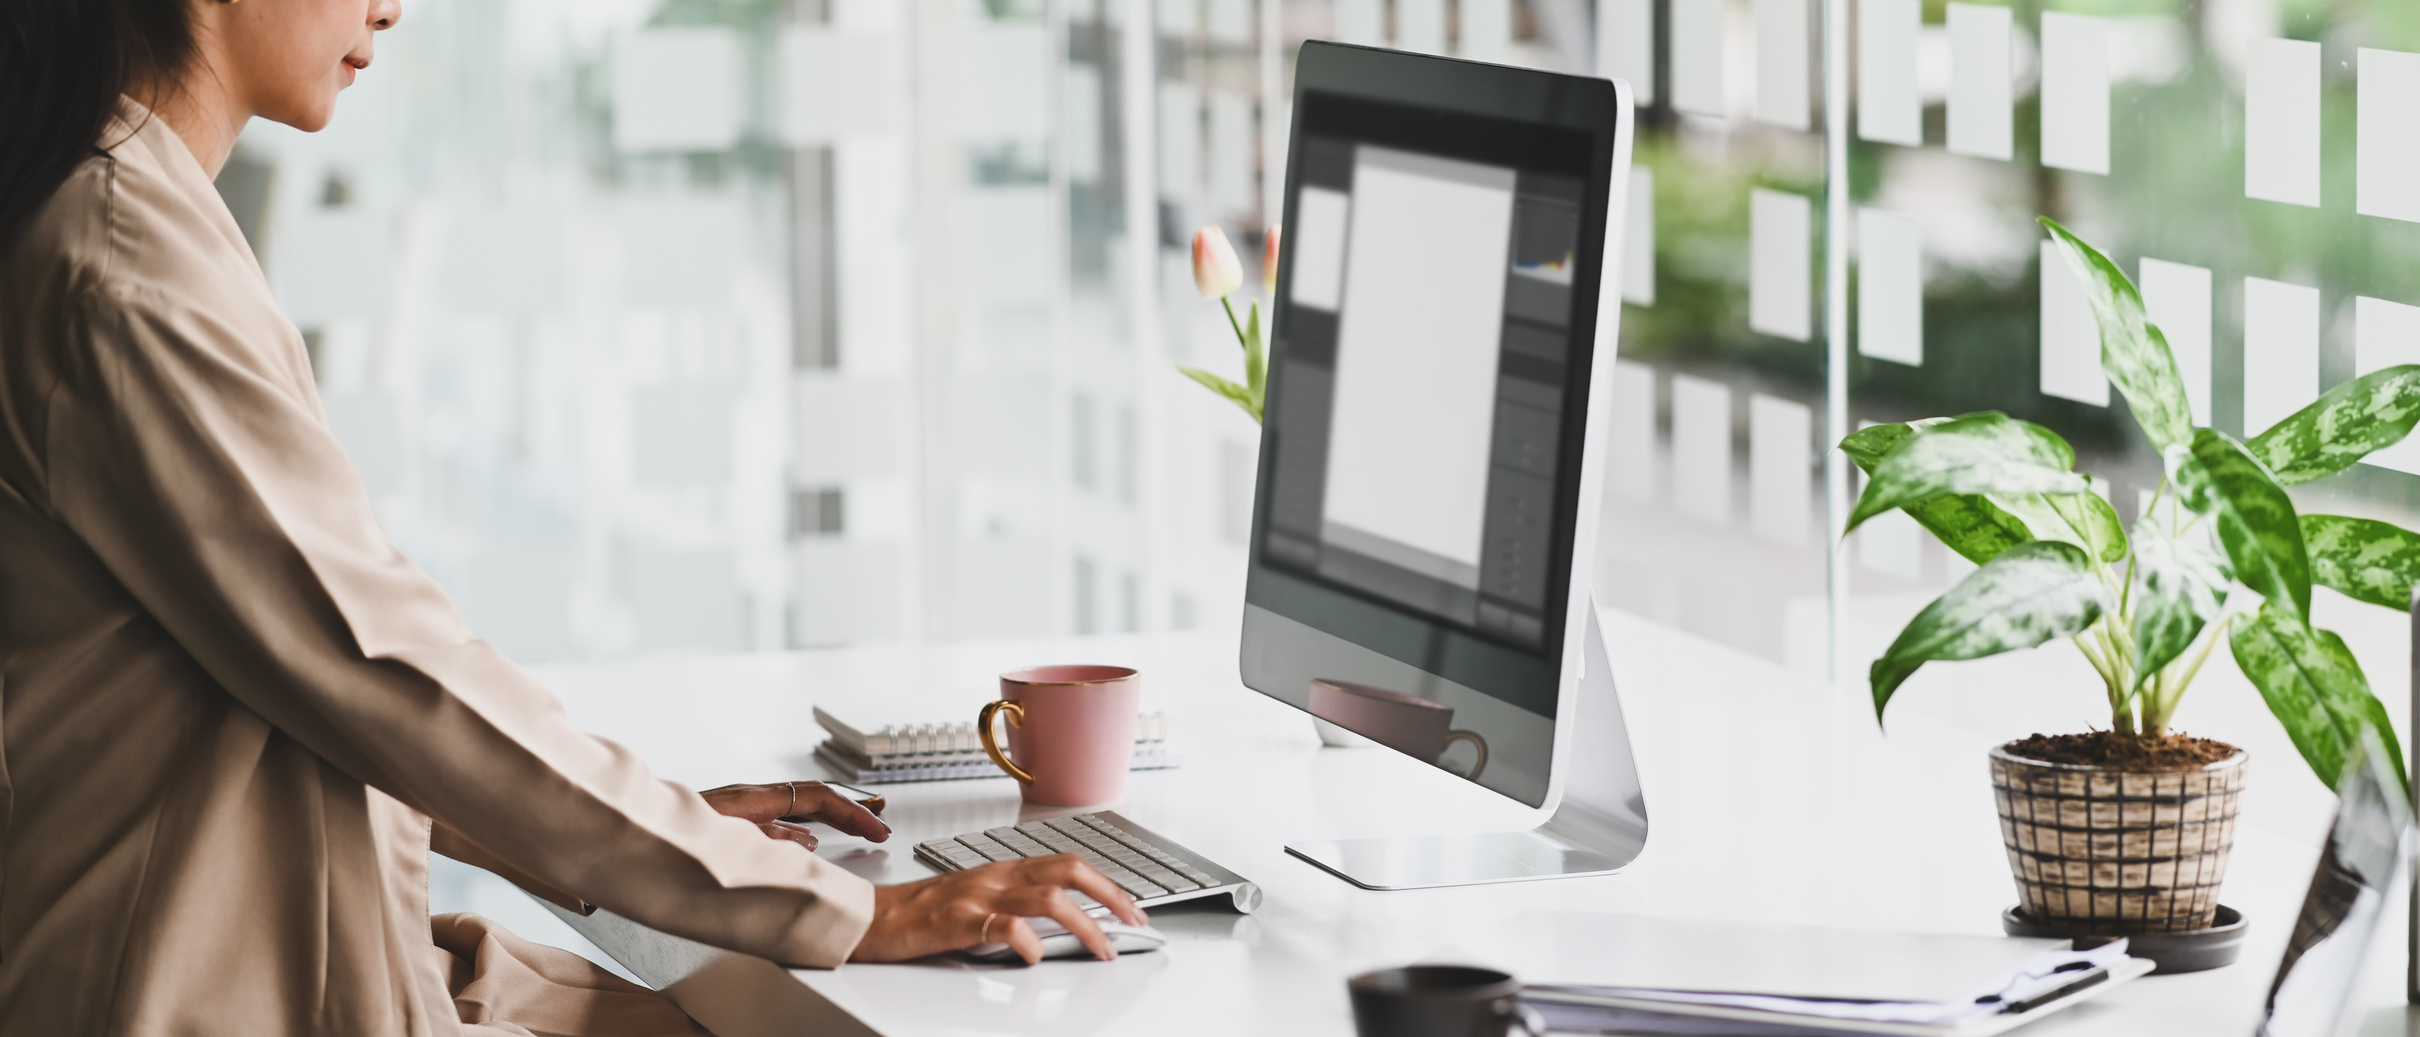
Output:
top-left (816, 699), bottom-right (1183, 786)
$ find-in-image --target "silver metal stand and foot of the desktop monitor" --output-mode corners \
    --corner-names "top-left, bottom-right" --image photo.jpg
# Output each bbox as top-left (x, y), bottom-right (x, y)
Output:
top-left (1285, 604), bottom-right (1648, 890)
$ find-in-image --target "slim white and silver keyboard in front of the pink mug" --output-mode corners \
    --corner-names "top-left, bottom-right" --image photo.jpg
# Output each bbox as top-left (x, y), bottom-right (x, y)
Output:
top-left (915, 810), bottom-right (1261, 914)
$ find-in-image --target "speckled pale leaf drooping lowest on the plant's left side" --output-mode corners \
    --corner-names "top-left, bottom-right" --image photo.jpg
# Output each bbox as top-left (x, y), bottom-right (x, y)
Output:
top-left (1868, 539), bottom-right (2105, 720)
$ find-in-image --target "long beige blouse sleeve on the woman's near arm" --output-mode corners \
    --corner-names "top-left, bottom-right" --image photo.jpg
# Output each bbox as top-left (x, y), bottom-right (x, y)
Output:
top-left (46, 279), bottom-right (874, 967)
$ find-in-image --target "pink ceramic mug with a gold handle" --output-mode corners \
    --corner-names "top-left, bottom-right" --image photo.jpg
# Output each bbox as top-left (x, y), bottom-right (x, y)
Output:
top-left (975, 667), bottom-right (1142, 807)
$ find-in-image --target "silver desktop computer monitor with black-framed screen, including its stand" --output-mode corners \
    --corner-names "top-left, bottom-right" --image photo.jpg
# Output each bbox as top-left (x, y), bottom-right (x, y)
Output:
top-left (1241, 41), bottom-right (1646, 887)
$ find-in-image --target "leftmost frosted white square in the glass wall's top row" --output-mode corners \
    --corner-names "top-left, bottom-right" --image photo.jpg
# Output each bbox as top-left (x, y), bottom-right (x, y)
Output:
top-left (612, 27), bottom-right (743, 152)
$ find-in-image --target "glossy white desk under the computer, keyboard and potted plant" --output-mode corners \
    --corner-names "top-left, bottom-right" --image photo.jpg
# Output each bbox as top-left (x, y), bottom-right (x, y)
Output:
top-left (500, 614), bottom-right (2420, 1037)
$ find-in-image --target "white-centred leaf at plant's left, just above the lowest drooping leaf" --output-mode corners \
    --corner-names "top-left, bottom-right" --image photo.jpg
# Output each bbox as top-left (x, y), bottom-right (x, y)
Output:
top-left (1844, 411), bottom-right (2091, 532)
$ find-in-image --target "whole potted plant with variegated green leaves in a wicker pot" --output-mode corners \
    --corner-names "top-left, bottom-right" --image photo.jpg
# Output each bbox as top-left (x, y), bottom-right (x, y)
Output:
top-left (1839, 218), bottom-right (2420, 935)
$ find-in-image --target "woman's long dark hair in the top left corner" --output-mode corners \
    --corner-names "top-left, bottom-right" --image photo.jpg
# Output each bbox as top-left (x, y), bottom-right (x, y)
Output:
top-left (0, 0), bottom-right (194, 249)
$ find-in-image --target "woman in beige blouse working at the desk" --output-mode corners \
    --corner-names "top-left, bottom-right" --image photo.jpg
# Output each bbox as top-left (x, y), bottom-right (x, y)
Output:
top-left (0, 0), bottom-right (1140, 1035)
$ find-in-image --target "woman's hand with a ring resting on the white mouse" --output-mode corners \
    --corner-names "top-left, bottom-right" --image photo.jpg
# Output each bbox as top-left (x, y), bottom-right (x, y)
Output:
top-left (849, 853), bottom-right (1145, 964)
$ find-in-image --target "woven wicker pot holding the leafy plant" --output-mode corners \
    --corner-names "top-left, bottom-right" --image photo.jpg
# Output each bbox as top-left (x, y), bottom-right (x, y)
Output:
top-left (1992, 747), bottom-right (2251, 935)
